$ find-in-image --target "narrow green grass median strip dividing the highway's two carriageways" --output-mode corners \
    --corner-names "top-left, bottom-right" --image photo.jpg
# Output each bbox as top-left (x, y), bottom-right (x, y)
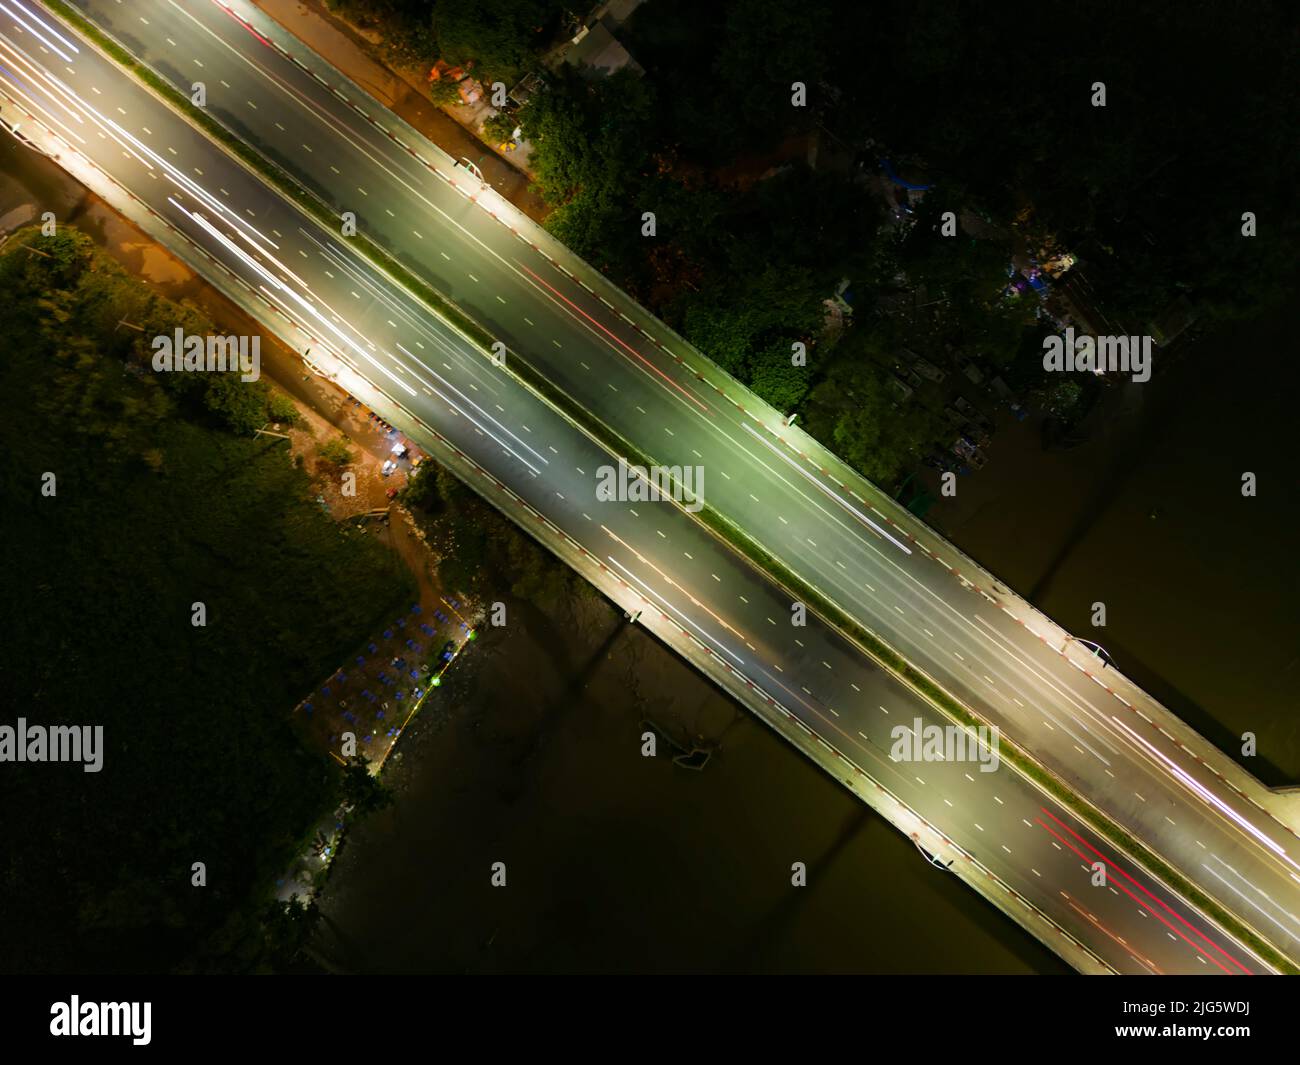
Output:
top-left (46, 0), bottom-right (1300, 974)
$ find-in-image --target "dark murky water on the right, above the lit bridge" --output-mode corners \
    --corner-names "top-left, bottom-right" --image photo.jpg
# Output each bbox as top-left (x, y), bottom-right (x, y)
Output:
top-left (928, 304), bottom-right (1300, 787)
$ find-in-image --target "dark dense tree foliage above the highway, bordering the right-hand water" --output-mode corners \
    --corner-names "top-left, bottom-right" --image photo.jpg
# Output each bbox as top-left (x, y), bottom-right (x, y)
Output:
top-left (521, 0), bottom-right (1300, 484)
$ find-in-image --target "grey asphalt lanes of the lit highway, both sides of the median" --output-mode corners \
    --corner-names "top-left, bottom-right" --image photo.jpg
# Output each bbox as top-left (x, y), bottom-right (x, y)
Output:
top-left (0, 0), bottom-right (1300, 971)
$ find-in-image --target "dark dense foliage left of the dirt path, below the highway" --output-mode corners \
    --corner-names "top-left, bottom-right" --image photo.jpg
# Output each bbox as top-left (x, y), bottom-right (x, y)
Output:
top-left (0, 229), bottom-right (411, 971)
